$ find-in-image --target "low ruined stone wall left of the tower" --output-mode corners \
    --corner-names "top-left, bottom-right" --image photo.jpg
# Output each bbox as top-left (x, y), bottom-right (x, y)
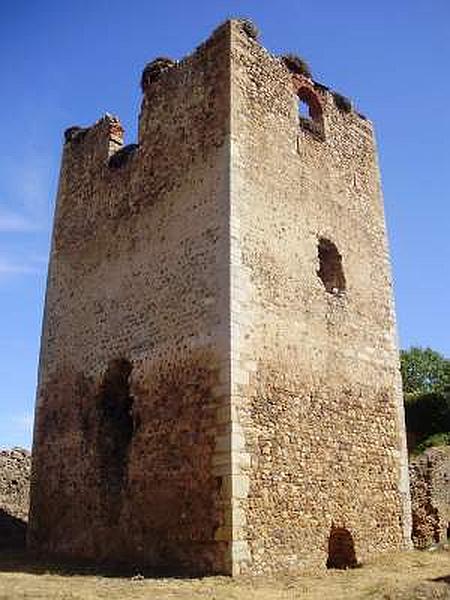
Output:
top-left (0, 448), bottom-right (31, 549)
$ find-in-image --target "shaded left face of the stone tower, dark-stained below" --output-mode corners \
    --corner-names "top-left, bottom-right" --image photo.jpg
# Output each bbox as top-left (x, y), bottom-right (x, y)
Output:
top-left (29, 27), bottom-right (229, 572)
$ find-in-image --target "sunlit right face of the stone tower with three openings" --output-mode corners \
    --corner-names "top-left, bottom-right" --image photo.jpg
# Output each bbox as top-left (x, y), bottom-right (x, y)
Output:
top-left (231, 27), bottom-right (410, 573)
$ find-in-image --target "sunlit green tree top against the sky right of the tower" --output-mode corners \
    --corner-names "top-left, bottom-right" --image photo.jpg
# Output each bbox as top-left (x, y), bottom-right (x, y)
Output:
top-left (400, 346), bottom-right (450, 400)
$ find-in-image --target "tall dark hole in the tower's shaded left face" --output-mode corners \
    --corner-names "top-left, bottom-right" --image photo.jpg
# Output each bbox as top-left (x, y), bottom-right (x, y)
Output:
top-left (97, 359), bottom-right (133, 494)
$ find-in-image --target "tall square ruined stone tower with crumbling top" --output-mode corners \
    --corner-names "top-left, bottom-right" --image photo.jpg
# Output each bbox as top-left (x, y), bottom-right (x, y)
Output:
top-left (29, 21), bottom-right (410, 574)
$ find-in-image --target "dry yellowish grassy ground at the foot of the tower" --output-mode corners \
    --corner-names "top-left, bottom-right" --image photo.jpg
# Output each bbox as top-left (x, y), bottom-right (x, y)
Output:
top-left (0, 550), bottom-right (450, 600)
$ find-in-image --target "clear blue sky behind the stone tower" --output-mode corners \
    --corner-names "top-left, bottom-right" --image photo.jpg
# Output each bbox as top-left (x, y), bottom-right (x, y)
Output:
top-left (0, 0), bottom-right (450, 447)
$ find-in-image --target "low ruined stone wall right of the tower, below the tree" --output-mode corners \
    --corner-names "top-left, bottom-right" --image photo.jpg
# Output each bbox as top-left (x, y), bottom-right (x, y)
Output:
top-left (409, 447), bottom-right (450, 548)
